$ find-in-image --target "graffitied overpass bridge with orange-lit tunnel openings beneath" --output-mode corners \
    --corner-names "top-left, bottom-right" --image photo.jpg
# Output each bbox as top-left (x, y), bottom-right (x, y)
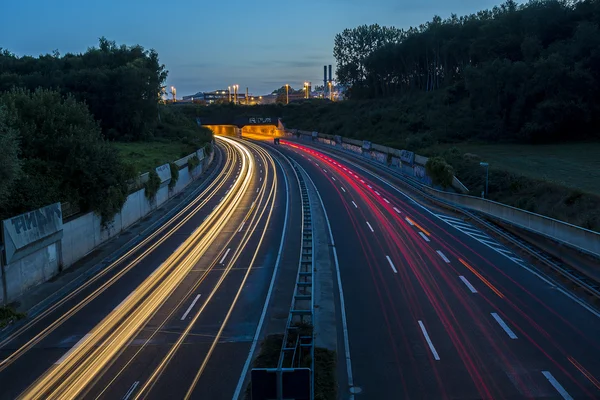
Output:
top-left (196, 116), bottom-right (284, 137)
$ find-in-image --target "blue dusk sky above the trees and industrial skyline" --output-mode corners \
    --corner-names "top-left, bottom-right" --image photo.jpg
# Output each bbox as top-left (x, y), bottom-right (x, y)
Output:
top-left (0, 0), bottom-right (510, 97)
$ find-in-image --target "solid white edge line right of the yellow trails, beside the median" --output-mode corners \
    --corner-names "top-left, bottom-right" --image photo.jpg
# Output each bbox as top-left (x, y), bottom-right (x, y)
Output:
top-left (232, 153), bottom-right (290, 400)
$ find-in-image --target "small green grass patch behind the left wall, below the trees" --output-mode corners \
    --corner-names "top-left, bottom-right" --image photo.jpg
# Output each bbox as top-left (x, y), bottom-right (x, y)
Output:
top-left (111, 142), bottom-right (194, 173)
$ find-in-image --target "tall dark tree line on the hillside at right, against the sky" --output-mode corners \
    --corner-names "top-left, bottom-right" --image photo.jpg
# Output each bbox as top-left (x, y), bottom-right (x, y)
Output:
top-left (334, 0), bottom-right (600, 142)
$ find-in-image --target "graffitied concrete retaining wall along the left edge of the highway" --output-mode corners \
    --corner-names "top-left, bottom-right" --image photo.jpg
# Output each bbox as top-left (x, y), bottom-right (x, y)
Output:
top-left (0, 145), bottom-right (214, 304)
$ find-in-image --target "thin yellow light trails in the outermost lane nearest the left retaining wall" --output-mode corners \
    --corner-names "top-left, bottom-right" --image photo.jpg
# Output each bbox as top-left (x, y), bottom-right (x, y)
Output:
top-left (0, 146), bottom-right (236, 372)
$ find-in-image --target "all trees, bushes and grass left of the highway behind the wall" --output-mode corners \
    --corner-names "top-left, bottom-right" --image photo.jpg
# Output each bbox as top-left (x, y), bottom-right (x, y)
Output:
top-left (0, 38), bottom-right (212, 221)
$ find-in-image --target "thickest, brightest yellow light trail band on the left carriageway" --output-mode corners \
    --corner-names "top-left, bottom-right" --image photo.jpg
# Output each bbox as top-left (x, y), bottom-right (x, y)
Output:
top-left (21, 137), bottom-right (254, 399)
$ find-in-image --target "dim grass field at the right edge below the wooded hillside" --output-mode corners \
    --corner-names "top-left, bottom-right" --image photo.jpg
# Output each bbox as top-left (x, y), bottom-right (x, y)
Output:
top-left (436, 143), bottom-right (600, 194)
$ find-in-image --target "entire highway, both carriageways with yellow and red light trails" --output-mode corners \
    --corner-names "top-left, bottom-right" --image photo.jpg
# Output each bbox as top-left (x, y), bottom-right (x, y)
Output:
top-left (0, 130), bottom-right (600, 399)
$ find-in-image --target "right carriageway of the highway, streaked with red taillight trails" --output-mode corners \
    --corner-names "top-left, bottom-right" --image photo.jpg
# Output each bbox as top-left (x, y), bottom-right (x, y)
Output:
top-left (272, 140), bottom-right (600, 399)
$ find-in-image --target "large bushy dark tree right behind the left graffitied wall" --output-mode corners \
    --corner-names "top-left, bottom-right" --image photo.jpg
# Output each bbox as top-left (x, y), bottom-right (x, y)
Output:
top-left (0, 89), bottom-right (134, 222)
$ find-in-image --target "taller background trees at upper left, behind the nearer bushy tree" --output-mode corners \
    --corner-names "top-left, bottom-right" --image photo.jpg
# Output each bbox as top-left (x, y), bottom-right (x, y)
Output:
top-left (0, 37), bottom-right (167, 140)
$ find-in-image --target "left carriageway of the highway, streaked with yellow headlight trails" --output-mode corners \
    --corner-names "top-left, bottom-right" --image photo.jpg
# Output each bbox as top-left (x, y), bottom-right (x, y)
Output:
top-left (0, 138), bottom-right (300, 399)
